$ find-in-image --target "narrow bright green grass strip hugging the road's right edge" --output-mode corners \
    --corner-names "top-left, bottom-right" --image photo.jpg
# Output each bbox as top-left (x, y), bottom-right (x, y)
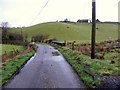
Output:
top-left (59, 48), bottom-right (96, 87)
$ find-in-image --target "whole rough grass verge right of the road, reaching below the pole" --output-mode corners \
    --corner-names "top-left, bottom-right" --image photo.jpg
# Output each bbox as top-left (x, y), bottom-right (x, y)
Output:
top-left (57, 46), bottom-right (120, 88)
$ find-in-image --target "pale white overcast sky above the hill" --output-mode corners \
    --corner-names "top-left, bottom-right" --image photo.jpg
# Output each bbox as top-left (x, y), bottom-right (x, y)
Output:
top-left (0, 0), bottom-right (120, 26)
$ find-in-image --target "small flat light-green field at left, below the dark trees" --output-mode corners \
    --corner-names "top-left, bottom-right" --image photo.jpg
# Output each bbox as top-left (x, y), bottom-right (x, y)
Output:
top-left (0, 44), bottom-right (24, 55)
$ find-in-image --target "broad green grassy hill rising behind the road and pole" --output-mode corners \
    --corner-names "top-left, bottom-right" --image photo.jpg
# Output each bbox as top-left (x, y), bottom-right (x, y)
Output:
top-left (10, 22), bottom-right (118, 43)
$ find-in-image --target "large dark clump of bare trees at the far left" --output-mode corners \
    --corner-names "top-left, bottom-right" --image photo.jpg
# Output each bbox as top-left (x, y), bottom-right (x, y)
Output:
top-left (1, 22), bottom-right (28, 45)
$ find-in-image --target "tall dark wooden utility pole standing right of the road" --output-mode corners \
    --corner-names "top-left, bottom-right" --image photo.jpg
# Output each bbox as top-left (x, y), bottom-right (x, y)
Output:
top-left (91, 0), bottom-right (96, 59)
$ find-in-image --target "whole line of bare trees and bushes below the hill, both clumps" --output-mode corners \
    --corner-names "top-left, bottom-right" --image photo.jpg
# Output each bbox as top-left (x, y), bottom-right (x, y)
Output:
top-left (0, 22), bottom-right (49, 45)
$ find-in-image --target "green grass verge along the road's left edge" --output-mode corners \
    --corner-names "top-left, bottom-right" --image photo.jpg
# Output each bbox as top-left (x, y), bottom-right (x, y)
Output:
top-left (0, 51), bottom-right (35, 85)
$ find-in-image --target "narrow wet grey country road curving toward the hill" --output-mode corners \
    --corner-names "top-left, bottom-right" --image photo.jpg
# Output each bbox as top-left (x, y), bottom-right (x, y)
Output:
top-left (5, 44), bottom-right (85, 88)
